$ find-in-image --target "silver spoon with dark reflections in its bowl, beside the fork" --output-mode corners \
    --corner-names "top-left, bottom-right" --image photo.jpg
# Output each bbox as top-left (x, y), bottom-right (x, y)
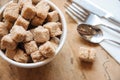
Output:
top-left (77, 24), bottom-right (120, 46)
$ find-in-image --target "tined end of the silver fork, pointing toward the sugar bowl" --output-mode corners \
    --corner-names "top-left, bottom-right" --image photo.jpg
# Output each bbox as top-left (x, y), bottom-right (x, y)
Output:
top-left (64, 3), bottom-right (89, 24)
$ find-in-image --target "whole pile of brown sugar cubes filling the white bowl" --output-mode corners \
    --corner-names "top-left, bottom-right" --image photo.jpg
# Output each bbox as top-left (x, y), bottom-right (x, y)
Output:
top-left (0, 0), bottom-right (62, 63)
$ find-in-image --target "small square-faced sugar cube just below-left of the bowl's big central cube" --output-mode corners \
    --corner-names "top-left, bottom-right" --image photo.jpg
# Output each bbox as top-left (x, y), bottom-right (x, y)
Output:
top-left (24, 41), bottom-right (38, 54)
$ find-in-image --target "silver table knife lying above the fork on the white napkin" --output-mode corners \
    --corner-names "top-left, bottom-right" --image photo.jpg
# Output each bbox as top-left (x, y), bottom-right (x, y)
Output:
top-left (72, 0), bottom-right (120, 26)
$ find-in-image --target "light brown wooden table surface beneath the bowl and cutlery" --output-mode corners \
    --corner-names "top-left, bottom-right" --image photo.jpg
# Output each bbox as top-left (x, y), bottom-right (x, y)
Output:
top-left (0, 0), bottom-right (120, 80)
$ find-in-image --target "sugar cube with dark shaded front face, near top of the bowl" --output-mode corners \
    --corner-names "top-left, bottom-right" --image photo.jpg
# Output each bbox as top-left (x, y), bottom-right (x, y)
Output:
top-left (21, 4), bottom-right (36, 20)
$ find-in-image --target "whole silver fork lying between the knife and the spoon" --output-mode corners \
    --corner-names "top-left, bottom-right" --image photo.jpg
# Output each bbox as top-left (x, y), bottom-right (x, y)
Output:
top-left (64, 3), bottom-right (120, 33)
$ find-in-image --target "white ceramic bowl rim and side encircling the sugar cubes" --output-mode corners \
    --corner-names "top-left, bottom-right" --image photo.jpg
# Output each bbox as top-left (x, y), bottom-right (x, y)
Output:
top-left (0, 0), bottom-right (67, 68)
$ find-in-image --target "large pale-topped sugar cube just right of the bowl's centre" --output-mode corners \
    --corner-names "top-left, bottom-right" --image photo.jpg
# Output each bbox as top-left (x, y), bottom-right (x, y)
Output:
top-left (31, 26), bottom-right (50, 43)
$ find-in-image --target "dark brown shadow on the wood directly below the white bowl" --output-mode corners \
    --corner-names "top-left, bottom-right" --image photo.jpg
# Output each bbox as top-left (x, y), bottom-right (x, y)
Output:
top-left (8, 63), bottom-right (57, 80)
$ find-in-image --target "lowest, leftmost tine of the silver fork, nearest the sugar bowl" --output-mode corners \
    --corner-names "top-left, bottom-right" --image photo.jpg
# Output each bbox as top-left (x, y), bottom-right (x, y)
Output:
top-left (64, 5), bottom-right (85, 21)
